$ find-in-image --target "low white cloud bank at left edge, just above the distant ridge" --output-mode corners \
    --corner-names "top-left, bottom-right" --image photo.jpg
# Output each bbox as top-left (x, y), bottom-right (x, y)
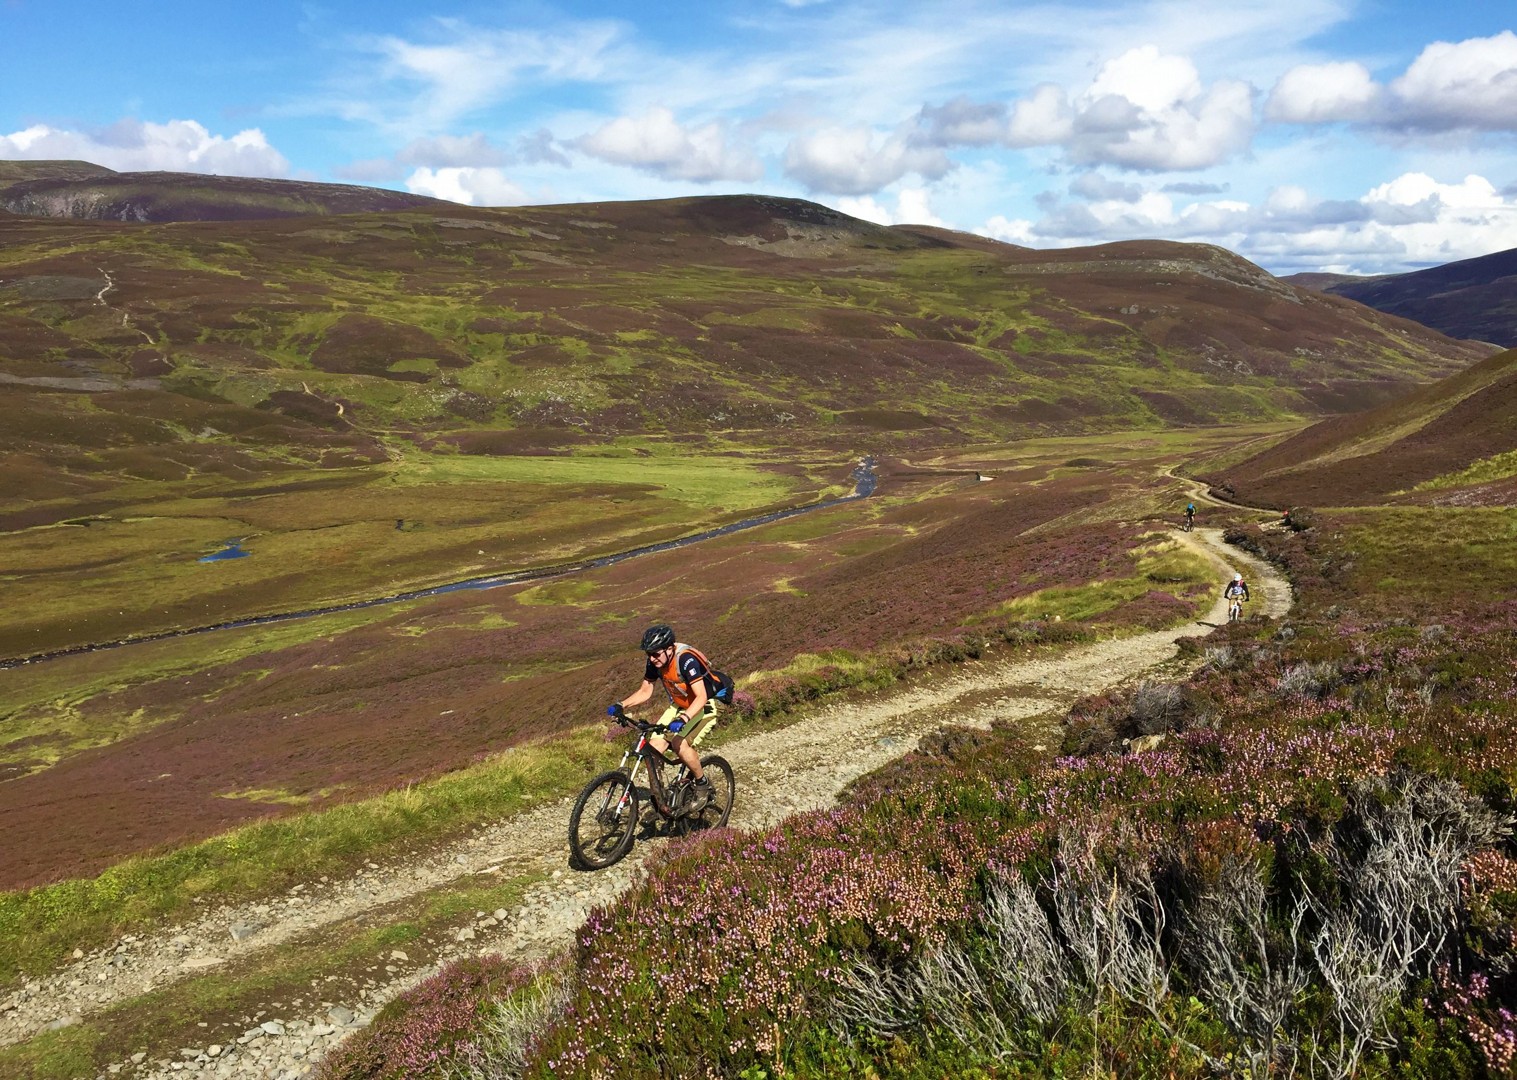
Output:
top-left (0, 120), bottom-right (290, 176)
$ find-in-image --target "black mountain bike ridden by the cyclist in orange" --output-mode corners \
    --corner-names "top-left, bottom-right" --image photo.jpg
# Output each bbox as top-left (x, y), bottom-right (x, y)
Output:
top-left (569, 716), bottom-right (737, 871)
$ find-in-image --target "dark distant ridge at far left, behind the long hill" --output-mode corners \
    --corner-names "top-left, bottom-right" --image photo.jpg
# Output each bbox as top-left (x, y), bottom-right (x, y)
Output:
top-left (0, 161), bottom-right (452, 221)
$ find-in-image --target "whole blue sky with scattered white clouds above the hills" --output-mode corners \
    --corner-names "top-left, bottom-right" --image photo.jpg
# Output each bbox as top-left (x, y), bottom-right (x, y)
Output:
top-left (0, 0), bottom-right (1517, 273)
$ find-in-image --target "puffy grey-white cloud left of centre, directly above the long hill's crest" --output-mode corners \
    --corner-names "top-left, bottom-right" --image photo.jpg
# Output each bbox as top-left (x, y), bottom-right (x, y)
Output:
top-left (576, 108), bottom-right (763, 184)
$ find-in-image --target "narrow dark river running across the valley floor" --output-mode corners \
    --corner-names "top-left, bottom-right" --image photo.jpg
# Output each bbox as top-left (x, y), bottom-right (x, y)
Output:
top-left (0, 457), bottom-right (878, 670)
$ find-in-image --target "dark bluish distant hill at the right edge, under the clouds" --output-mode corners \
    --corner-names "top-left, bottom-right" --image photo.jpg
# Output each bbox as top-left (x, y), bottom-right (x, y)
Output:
top-left (1286, 249), bottom-right (1517, 349)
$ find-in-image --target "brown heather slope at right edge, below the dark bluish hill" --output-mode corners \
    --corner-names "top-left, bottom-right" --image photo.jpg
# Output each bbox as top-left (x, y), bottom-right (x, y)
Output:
top-left (1208, 350), bottom-right (1517, 507)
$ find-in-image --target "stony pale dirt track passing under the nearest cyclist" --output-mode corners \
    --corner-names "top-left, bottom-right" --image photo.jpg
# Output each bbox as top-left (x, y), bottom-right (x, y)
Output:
top-left (0, 529), bottom-right (1291, 1080)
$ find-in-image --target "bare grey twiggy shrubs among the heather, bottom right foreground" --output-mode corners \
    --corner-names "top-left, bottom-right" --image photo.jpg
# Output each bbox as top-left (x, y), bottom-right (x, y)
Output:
top-left (831, 778), bottom-right (1512, 1080)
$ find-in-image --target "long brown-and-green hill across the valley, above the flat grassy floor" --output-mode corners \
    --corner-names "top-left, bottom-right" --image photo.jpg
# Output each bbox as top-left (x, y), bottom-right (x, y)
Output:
top-left (0, 174), bottom-right (1488, 494)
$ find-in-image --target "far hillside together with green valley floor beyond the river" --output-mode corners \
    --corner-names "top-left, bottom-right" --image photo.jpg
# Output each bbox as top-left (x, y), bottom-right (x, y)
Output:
top-left (0, 175), bottom-right (1488, 658)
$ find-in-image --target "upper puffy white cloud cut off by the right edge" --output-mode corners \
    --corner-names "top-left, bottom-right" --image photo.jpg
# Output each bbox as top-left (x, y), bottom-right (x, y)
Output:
top-left (1391, 30), bottom-right (1517, 130)
